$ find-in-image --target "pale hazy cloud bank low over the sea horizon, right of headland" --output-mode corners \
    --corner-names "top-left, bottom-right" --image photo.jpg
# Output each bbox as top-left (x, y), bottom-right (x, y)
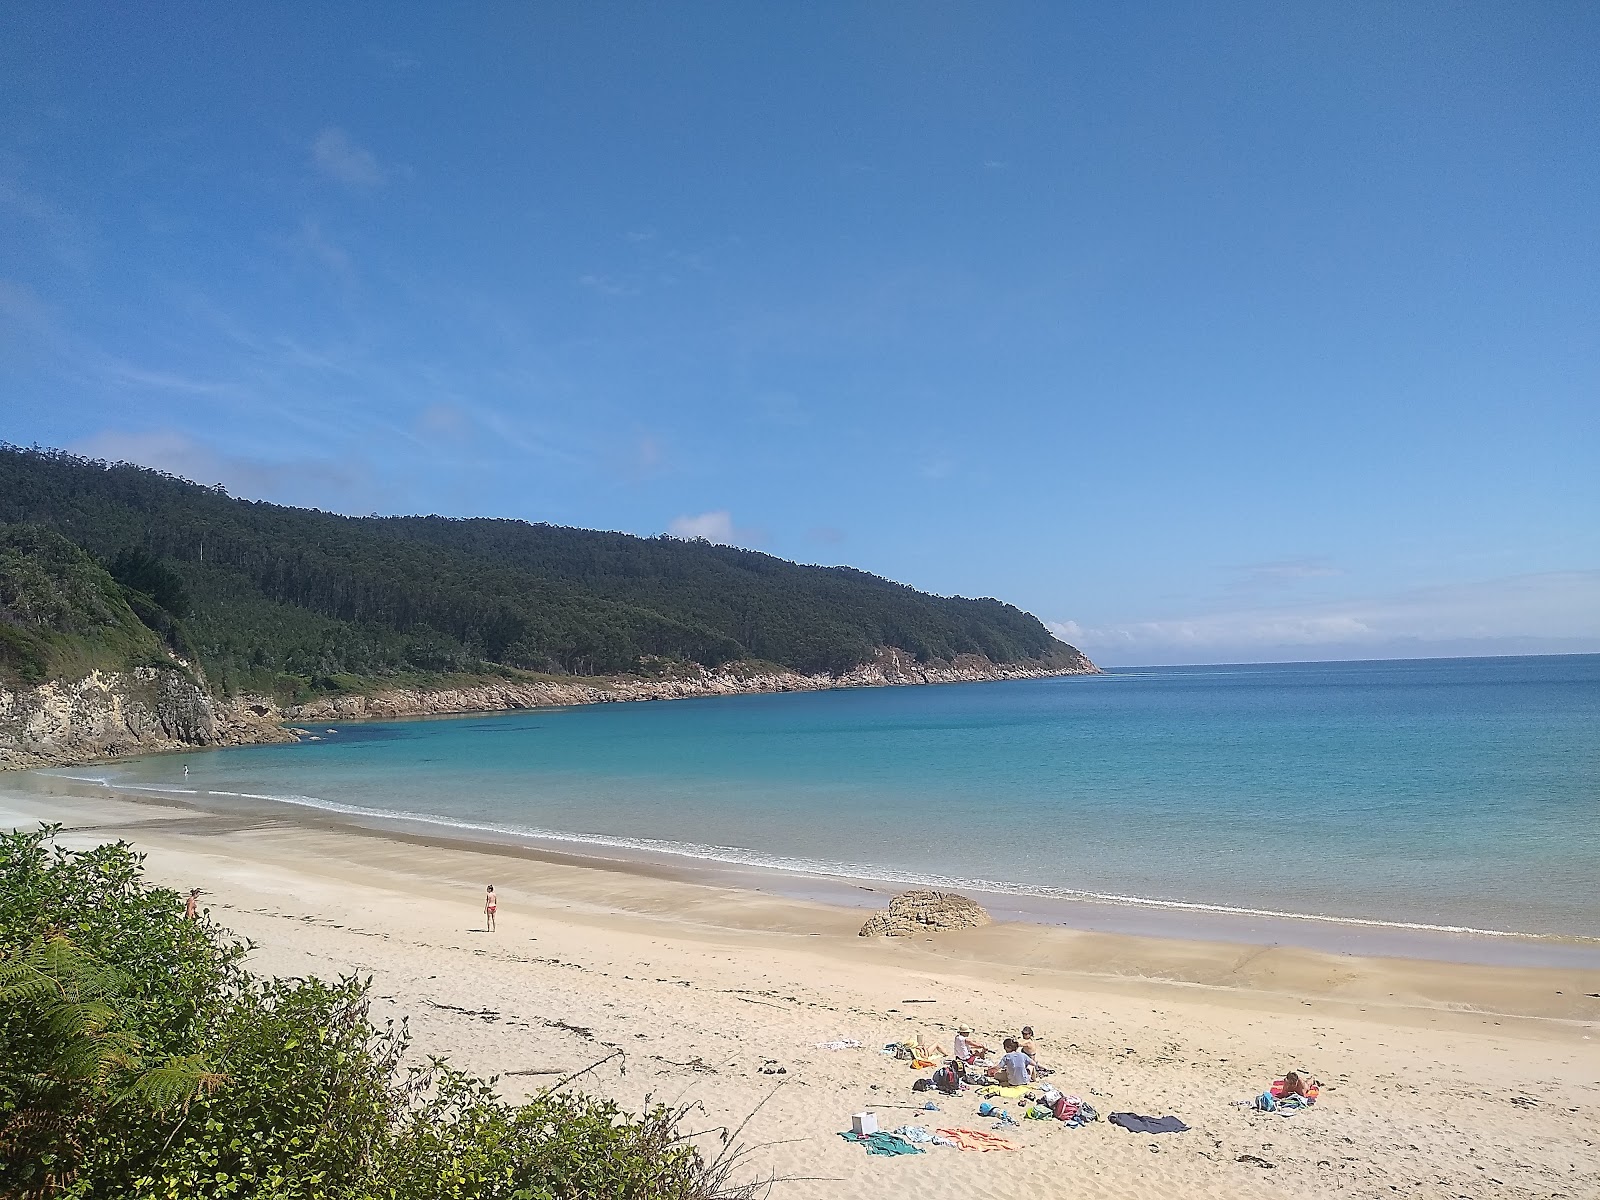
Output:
top-left (1048, 571), bottom-right (1600, 662)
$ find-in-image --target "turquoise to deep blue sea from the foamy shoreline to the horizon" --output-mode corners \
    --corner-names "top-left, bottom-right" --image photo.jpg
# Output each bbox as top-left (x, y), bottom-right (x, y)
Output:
top-left (58, 654), bottom-right (1600, 936)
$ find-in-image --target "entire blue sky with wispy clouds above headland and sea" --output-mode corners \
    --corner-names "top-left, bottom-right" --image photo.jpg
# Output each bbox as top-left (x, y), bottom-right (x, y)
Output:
top-left (0, 3), bottom-right (1600, 662)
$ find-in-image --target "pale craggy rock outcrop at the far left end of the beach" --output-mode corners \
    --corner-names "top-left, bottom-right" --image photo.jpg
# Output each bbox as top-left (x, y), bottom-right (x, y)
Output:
top-left (0, 667), bottom-right (294, 770)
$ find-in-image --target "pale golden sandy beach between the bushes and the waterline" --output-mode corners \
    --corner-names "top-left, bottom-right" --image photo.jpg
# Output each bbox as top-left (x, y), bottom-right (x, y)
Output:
top-left (0, 789), bottom-right (1600, 1200)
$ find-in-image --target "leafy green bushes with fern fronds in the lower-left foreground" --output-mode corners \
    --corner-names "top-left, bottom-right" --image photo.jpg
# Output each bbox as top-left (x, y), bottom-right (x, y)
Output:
top-left (0, 827), bottom-right (755, 1200)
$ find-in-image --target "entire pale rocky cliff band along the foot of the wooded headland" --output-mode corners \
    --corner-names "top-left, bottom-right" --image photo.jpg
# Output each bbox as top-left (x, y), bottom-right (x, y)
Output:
top-left (0, 650), bottom-right (1099, 770)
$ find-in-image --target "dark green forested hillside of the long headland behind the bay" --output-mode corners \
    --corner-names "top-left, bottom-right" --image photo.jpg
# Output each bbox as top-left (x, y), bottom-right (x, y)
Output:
top-left (0, 445), bottom-right (1086, 694)
